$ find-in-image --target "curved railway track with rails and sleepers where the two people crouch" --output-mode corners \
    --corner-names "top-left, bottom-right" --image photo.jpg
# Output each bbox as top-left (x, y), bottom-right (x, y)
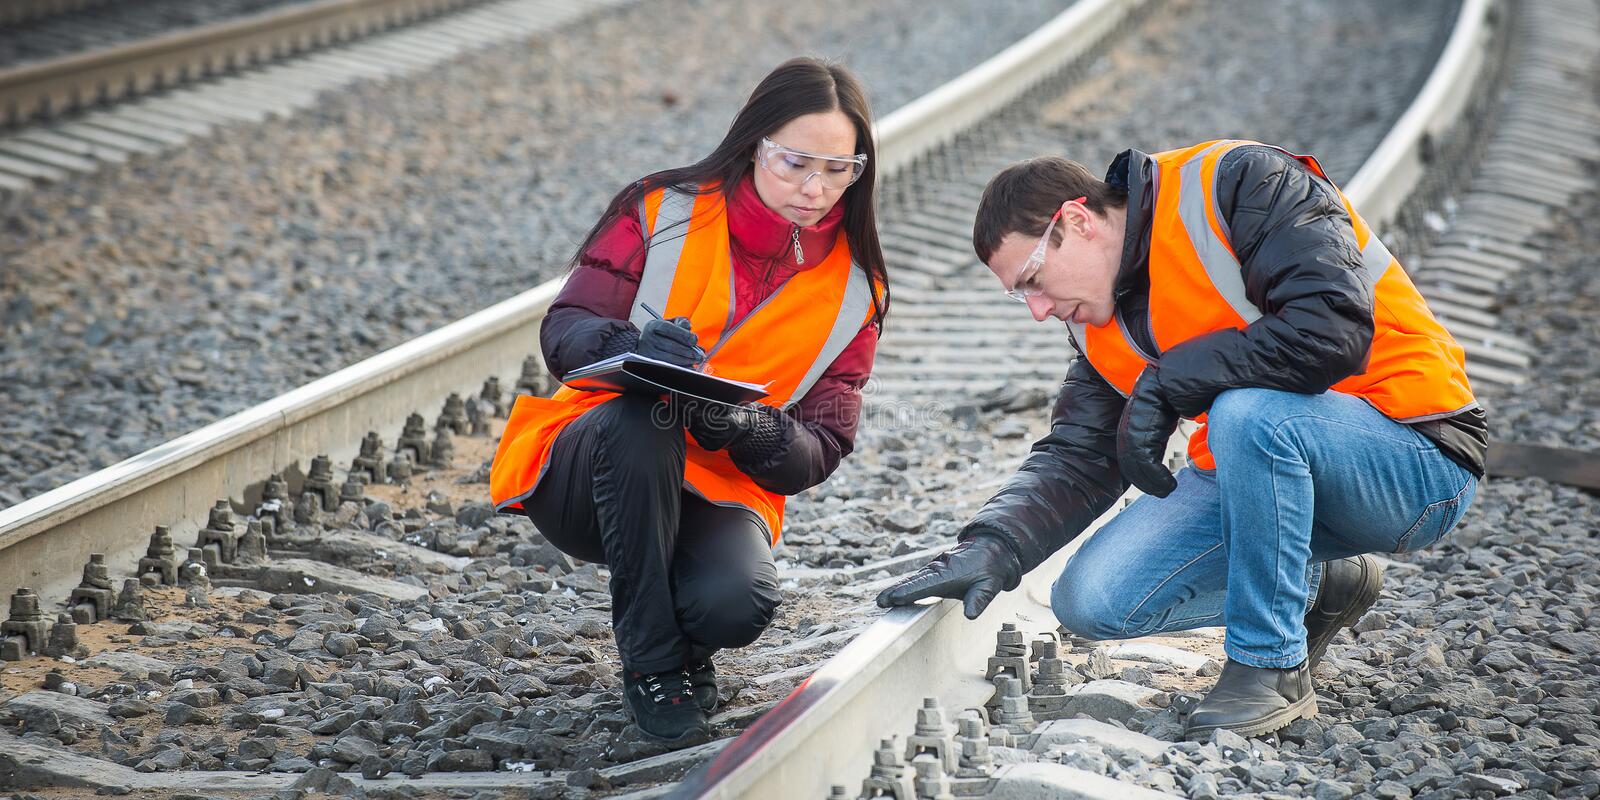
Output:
top-left (0, 0), bottom-right (1600, 797)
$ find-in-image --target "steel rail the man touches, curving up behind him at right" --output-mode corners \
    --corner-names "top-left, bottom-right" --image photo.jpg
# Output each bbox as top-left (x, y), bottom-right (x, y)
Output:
top-left (670, 0), bottom-right (1496, 798)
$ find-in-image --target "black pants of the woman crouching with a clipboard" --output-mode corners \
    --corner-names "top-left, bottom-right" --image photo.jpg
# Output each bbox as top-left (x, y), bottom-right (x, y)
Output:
top-left (522, 395), bottom-right (782, 672)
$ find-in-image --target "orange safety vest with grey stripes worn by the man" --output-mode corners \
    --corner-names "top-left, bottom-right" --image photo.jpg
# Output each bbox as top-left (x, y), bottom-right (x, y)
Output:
top-left (1067, 139), bottom-right (1477, 469)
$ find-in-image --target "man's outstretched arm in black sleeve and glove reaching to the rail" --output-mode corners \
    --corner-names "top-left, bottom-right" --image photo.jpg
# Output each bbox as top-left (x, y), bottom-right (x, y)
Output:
top-left (878, 358), bottom-right (1128, 619)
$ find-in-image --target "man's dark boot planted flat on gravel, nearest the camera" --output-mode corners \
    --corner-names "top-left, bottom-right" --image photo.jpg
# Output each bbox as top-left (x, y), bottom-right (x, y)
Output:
top-left (1184, 661), bottom-right (1317, 739)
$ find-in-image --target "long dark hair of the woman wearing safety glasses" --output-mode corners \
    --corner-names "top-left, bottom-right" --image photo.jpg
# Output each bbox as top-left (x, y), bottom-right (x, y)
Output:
top-left (568, 58), bottom-right (890, 330)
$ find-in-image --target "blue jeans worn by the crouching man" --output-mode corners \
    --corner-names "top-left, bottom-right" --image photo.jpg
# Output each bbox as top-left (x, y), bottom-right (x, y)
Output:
top-left (1051, 389), bottom-right (1478, 667)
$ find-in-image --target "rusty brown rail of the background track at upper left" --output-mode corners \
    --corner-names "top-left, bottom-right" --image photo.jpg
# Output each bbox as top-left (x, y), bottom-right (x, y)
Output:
top-left (0, 0), bottom-right (482, 126)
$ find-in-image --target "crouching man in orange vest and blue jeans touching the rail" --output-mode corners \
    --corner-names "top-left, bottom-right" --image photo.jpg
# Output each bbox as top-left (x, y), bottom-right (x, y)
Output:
top-left (878, 141), bottom-right (1488, 738)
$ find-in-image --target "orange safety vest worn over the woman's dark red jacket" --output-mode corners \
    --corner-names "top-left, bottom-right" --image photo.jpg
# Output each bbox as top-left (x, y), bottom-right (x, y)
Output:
top-left (490, 189), bottom-right (872, 544)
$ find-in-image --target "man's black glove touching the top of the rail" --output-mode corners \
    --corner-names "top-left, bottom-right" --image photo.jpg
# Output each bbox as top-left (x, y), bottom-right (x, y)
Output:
top-left (878, 533), bottom-right (1022, 619)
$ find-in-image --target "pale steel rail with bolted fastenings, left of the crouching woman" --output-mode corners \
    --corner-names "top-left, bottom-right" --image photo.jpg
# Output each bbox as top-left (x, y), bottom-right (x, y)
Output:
top-left (0, 282), bottom-right (560, 597)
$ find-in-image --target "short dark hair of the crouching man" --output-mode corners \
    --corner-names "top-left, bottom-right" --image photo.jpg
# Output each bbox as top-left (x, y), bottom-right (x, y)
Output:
top-left (973, 155), bottom-right (1128, 264)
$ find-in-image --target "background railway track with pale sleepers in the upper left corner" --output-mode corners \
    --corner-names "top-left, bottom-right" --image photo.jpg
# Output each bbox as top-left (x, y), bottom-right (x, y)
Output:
top-left (0, 0), bottom-right (619, 200)
